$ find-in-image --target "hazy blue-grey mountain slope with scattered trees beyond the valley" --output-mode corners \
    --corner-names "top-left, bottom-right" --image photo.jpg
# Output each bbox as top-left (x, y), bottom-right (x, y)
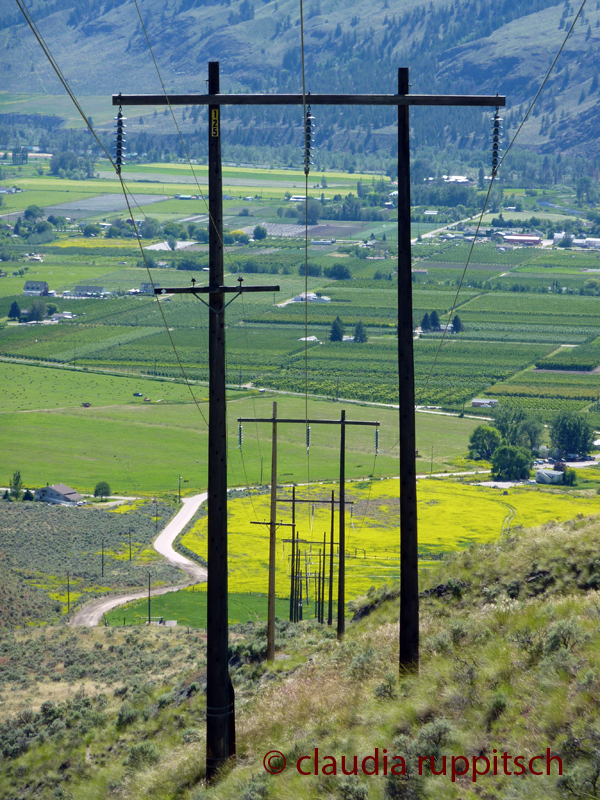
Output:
top-left (0, 0), bottom-right (600, 159)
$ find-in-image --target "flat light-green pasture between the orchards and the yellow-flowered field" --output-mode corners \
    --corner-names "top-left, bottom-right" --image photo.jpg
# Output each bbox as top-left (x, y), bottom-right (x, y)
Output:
top-left (0, 362), bottom-right (476, 494)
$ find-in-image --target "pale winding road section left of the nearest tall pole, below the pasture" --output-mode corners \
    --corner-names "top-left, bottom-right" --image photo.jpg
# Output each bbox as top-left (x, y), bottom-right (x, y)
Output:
top-left (69, 492), bottom-right (208, 627)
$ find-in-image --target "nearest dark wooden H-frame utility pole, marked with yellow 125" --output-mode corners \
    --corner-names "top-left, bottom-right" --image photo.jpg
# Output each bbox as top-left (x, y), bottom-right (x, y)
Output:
top-left (113, 67), bottom-right (505, 764)
